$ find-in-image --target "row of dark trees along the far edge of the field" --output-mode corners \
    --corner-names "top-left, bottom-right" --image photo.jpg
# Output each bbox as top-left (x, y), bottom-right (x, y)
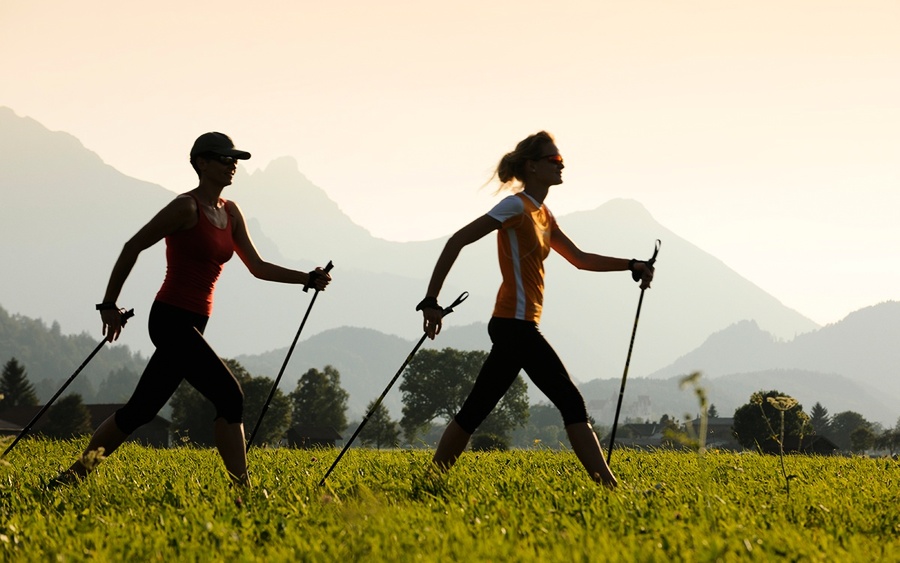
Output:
top-left (0, 354), bottom-right (900, 455)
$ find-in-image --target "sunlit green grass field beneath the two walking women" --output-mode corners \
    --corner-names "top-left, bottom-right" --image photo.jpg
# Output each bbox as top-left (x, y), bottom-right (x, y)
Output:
top-left (0, 440), bottom-right (900, 562)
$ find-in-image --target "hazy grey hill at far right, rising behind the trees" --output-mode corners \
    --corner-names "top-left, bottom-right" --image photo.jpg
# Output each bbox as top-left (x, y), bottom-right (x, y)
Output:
top-left (628, 301), bottom-right (900, 426)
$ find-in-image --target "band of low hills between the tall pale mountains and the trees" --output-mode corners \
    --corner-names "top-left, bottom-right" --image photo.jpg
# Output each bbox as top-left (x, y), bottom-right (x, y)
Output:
top-left (0, 303), bottom-right (898, 427)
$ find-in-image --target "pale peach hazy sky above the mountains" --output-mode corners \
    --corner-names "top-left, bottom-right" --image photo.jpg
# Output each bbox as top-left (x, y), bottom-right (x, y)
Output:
top-left (0, 0), bottom-right (900, 324)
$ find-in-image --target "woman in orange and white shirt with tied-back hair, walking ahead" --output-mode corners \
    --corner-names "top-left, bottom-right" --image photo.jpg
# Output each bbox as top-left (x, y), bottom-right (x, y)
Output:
top-left (416, 131), bottom-right (653, 487)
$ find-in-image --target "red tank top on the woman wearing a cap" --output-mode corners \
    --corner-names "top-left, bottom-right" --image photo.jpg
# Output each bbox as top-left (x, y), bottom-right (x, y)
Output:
top-left (156, 194), bottom-right (234, 316)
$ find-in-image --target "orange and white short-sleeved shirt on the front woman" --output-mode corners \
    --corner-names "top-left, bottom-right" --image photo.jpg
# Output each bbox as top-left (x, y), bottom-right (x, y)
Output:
top-left (487, 192), bottom-right (556, 323)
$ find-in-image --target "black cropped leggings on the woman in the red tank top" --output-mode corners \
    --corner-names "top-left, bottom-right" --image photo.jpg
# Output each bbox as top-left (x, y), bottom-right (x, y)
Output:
top-left (116, 301), bottom-right (244, 434)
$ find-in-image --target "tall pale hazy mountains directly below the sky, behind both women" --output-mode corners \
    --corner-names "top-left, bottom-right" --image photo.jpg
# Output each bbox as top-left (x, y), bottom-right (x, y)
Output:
top-left (0, 108), bottom-right (897, 428)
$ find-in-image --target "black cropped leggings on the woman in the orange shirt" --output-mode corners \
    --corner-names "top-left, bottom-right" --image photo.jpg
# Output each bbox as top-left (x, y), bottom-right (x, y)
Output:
top-left (455, 317), bottom-right (588, 434)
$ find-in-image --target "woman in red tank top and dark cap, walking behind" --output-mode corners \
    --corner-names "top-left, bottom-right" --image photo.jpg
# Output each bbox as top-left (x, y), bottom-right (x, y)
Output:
top-left (57, 133), bottom-right (331, 485)
